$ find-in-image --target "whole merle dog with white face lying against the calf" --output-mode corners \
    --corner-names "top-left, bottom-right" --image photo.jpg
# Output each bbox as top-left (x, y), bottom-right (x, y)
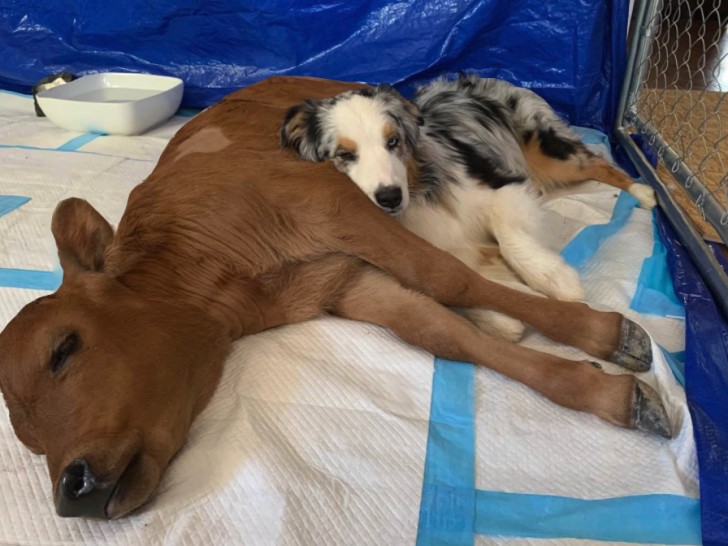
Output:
top-left (281, 71), bottom-right (654, 337)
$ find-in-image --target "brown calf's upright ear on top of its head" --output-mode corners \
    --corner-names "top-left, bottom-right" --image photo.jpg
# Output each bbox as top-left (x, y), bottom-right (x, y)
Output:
top-left (51, 198), bottom-right (114, 275)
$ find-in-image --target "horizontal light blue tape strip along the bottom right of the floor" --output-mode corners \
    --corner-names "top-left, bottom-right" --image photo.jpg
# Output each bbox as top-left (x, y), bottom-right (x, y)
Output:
top-left (475, 491), bottom-right (701, 544)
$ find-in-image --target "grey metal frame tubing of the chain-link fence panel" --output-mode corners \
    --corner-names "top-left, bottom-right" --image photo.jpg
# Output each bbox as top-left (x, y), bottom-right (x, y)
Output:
top-left (614, 0), bottom-right (728, 317)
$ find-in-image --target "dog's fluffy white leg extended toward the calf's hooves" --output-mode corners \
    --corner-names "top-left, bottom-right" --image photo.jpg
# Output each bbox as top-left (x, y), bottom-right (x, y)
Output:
top-left (487, 184), bottom-right (584, 301)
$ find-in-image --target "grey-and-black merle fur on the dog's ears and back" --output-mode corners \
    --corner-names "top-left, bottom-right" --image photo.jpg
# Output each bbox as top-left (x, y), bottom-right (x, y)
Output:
top-left (281, 75), bottom-right (593, 204)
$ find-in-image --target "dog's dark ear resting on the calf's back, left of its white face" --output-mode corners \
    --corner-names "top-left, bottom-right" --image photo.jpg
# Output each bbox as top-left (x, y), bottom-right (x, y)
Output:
top-left (280, 100), bottom-right (326, 162)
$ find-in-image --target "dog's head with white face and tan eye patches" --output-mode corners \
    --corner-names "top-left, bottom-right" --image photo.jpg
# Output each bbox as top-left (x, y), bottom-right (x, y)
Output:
top-left (281, 85), bottom-right (421, 214)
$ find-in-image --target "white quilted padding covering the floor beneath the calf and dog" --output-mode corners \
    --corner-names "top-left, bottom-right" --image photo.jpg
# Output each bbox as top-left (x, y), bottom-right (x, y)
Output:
top-left (0, 93), bottom-right (698, 545)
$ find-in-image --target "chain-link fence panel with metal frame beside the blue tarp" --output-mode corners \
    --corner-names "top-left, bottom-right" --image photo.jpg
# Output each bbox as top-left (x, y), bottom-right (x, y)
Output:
top-left (616, 0), bottom-right (728, 311)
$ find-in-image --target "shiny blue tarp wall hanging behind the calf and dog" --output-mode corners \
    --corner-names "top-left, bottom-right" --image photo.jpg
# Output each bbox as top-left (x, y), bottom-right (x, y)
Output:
top-left (0, 0), bottom-right (628, 130)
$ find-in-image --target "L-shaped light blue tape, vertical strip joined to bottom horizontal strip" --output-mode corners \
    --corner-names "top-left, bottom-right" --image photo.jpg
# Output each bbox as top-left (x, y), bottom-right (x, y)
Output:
top-left (417, 353), bottom-right (701, 546)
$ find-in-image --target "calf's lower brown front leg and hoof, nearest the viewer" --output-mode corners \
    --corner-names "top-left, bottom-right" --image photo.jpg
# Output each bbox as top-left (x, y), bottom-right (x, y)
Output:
top-left (333, 266), bottom-right (671, 438)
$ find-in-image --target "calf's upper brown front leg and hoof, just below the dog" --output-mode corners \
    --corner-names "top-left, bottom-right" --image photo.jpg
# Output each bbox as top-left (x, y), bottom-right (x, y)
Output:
top-left (324, 191), bottom-right (652, 371)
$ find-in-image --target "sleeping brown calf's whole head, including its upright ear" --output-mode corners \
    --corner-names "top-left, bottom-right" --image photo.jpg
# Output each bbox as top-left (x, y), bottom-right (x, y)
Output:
top-left (0, 199), bottom-right (229, 518)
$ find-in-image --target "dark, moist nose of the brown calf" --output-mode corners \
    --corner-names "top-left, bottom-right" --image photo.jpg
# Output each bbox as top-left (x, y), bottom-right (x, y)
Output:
top-left (56, 459), bottom-right (113, 518)
